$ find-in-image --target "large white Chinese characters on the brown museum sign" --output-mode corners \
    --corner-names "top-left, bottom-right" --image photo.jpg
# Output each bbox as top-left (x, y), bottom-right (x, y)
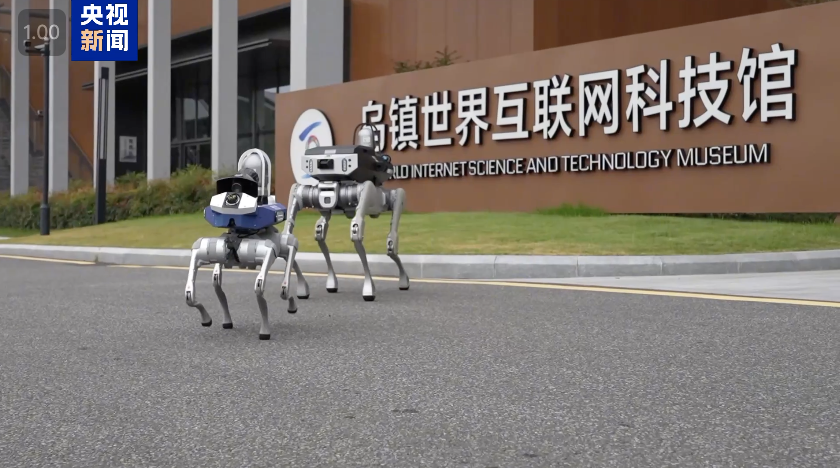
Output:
top-left (362, 44), bottom-right (797, 151)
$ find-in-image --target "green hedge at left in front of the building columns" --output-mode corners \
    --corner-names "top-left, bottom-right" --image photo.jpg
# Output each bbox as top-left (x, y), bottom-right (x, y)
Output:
top-left (0, 166), bottom-right (216, 230)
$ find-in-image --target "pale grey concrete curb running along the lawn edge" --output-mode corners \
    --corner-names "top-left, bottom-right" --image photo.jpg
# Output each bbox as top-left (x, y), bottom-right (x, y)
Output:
top-left (0, 244), bottom-right (840, 279)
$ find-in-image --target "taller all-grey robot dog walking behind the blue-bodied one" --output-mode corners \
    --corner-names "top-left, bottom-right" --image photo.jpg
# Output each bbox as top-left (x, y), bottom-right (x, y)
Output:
top-left (283, 124), bottom-right (409, 301)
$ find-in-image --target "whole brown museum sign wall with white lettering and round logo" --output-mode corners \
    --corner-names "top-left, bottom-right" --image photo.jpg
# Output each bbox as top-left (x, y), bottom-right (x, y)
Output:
top-left (276, 2), bottom-right (840, 213)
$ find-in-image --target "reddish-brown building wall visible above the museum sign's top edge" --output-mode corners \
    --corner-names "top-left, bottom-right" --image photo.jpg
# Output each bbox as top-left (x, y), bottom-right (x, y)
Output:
top-left (350, 0), bottom-right (789, 80)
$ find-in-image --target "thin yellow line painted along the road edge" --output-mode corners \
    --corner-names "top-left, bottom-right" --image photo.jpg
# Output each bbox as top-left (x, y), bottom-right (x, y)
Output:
top-left (110, 265), bottom-right (840, 308)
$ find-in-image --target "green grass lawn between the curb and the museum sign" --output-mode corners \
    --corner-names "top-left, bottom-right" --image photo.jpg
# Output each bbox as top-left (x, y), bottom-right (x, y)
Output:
top-left (0, 211), bottom-right (840, 255)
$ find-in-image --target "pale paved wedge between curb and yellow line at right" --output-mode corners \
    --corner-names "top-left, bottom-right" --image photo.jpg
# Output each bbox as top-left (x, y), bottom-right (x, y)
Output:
top-left (508, 270), bottom-right (840, 302)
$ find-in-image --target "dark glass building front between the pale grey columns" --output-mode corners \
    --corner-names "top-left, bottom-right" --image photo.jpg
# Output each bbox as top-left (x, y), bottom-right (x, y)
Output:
top-left (85, 5), bottom-right (289, 176)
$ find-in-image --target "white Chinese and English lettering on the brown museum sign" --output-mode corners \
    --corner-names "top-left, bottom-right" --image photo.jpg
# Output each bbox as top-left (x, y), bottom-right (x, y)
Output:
top-left (361, 43), bottom-right (797, 179)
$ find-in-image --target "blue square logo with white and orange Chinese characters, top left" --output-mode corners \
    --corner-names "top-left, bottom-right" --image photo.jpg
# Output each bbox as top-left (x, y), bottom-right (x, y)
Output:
top-left (70, 0), bottom-right (138, 62)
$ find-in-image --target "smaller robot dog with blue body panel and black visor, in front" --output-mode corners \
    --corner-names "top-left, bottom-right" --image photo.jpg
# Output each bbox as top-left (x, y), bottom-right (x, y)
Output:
top-left (184, 148), bottom-right (309, 340)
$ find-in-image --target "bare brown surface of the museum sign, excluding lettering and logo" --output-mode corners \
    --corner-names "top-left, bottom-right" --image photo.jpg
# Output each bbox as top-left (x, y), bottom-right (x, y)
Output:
top-left (276, 2), bottom-right (840, 213)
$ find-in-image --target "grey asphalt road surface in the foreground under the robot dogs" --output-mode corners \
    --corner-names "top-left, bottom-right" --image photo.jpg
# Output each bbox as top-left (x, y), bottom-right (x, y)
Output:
top-left (0, 258), bottom-right (840, 467)
